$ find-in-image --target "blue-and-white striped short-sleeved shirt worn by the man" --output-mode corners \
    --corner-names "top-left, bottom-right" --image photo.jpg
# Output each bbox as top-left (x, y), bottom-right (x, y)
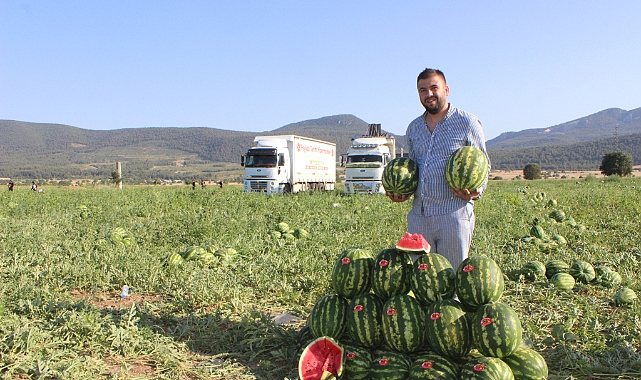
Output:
top-left (406, 104), bottom-right (489, 216)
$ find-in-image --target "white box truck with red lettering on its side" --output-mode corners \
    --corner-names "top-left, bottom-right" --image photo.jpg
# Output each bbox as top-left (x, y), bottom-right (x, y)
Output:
top-left (240, 135), bottom-right (337, 194)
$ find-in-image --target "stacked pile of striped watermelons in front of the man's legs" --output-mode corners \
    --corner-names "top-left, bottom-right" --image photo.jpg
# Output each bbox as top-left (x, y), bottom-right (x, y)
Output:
top-left (299, 235), bottom-right (548, 380)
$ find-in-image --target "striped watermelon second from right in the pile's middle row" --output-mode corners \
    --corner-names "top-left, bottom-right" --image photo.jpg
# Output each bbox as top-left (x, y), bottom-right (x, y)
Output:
top-left (425, 299), bottom-right (472, 359)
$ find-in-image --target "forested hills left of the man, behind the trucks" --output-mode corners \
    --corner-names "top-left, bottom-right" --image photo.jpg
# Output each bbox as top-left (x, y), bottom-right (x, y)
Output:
top-left (0, 115), bottom-right (403, 180)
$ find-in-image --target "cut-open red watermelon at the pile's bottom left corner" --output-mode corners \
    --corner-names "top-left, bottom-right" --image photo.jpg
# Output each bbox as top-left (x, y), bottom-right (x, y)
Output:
top-left (298, 336), bottom-right (343, 380)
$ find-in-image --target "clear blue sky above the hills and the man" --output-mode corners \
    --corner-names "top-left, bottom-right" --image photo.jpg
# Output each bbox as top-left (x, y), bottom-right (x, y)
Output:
top-left (0, 0), bottom-right (641, 140)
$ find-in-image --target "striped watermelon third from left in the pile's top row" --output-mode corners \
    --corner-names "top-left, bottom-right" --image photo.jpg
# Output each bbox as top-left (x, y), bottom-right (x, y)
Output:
top-left (410, 253), bottom-right (456, 305)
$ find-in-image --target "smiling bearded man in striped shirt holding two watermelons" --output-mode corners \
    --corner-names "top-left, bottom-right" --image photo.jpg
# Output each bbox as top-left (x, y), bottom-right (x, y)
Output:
top-left (387, 69), bottom-right (489, 270)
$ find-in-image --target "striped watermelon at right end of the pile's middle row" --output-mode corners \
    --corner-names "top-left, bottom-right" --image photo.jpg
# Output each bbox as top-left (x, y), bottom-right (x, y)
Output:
top-left (471, 302), bottom-right (523, 358)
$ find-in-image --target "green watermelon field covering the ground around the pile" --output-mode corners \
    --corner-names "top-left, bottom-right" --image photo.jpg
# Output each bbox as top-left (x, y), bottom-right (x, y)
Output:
top-left (0, 176), bottom-right (641, 379)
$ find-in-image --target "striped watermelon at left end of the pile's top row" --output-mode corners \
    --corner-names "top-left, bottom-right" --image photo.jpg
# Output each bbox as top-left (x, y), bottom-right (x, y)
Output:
top-left (332, 247), bottom-right (374, 299)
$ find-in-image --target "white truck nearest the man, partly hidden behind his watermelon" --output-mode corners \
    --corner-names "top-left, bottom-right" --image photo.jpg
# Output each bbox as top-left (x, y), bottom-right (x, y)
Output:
top-left (341, 124), bottom-right (396, 194)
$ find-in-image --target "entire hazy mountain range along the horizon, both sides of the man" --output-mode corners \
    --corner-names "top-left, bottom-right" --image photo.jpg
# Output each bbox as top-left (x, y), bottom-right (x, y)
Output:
top-left (0, 108), bottom-right (641, 180)
